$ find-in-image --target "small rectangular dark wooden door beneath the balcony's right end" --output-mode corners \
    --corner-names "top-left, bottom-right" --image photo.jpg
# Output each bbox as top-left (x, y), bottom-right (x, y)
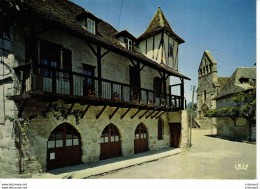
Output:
top-left (170, 123), bottom-right (181, 148)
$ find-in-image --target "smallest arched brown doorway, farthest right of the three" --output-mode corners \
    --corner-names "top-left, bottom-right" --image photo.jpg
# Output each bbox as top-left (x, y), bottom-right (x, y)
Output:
top-left (134, 123), bottom-right (148, 154)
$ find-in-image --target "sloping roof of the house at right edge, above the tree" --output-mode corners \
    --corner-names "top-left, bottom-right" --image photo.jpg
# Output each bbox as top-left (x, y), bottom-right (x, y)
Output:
top-left (214, 68), bottom-right (256, 99)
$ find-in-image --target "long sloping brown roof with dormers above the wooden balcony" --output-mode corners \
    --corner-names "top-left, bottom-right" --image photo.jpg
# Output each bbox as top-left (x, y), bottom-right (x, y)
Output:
top-left (18, 0), bottom-right (190, 80)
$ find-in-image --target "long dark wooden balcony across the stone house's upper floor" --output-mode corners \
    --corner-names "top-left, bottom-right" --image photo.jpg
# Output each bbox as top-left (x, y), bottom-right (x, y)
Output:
top-left (9, 64), bottom-right (186, 111)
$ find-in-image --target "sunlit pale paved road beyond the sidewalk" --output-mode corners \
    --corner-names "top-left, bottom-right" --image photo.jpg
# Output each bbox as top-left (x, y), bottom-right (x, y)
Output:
top-left (95, 129), bottom-right (256, 179)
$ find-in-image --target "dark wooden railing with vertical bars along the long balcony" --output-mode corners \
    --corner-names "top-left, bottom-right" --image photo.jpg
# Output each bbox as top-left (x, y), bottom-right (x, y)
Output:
top-left (15, 64), bottom-right (185, 110)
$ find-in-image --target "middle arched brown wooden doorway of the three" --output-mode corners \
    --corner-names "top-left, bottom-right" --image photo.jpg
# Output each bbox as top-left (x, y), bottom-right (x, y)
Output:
top-left (100, 123), bottom-right (122, 160)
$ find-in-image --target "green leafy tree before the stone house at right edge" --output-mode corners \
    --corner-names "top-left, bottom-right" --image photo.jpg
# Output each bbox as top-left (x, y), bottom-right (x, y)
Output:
top-left (205, 88), bottom-right (256, 141)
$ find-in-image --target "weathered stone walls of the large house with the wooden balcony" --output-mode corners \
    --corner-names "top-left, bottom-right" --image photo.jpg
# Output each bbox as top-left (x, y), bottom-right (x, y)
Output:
top-left (0, 1), bottom-right (188, 177)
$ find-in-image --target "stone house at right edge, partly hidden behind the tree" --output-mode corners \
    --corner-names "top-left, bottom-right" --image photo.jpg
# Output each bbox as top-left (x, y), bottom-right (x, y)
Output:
top-left (214, 68), bottom-right (256, 140)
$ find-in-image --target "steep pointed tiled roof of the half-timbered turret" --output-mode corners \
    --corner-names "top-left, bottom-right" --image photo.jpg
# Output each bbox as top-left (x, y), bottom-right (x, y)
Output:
top-left (138, 7), bottom-right (185, 44)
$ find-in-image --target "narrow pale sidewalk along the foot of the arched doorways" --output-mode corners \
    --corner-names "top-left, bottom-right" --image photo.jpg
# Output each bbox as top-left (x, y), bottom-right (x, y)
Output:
top-left (32, 148), bottom-right (183, 179)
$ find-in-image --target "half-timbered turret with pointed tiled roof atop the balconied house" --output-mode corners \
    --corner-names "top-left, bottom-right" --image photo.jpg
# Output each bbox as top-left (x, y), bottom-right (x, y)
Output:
top-left (137, 7), bottom-right (184, 71)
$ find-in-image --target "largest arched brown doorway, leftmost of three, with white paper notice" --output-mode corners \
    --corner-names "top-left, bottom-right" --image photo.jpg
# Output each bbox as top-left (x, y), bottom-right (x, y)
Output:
top-left (47, 123), bottom-right (81, 170)
